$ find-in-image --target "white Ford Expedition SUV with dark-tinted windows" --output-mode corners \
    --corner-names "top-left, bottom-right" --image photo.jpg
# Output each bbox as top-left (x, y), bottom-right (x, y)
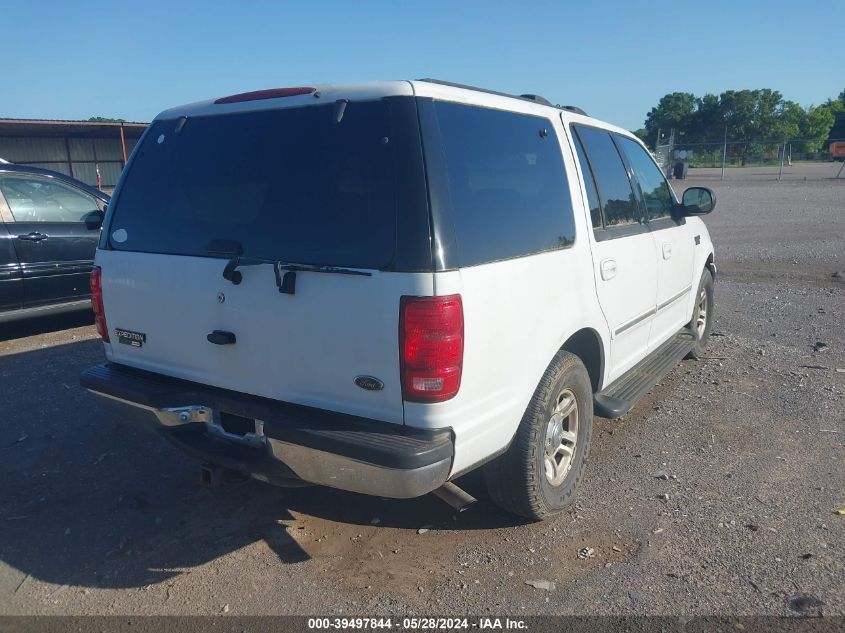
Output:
top-left (82, 80), bottom-right (715, 518)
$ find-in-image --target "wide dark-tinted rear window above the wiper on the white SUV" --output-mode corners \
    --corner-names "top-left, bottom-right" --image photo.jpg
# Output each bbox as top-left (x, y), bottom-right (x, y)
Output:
top-left (109, 100), bottom-right (397, 268)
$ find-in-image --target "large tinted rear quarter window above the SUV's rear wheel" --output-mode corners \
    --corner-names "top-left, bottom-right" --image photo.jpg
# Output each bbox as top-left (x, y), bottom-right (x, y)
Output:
top-left (434, 101), bottom-right (575, 266)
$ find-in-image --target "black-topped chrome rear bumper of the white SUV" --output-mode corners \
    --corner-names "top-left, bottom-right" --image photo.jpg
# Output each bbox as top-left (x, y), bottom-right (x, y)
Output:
top-left (80, 363), bottom-right (454, 499)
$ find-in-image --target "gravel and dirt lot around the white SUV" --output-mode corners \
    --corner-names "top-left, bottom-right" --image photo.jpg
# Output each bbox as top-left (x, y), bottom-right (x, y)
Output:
top-left (0, 165), bottom-right (845, 615)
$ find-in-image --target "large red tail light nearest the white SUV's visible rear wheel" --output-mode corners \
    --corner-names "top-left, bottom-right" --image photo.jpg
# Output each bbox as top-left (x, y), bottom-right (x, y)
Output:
top-left (399, 295), bottom-right (464, 402)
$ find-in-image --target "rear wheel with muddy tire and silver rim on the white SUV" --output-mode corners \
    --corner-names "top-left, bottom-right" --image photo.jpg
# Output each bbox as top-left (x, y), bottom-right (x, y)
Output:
top-left (484, 351), bottom-right (593, 520)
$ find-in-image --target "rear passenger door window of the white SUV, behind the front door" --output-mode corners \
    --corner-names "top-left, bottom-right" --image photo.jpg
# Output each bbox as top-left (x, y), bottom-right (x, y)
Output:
top-left (573, 125), bottom-right (640, 229)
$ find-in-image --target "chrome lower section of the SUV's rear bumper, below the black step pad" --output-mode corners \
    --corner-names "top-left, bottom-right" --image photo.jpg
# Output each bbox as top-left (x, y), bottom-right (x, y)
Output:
top-left (88, 388), bottom-right (452, 499)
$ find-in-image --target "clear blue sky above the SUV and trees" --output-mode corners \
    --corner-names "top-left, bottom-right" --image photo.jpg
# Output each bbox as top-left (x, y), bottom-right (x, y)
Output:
top-left (0, 0), bottom-right (845, 129)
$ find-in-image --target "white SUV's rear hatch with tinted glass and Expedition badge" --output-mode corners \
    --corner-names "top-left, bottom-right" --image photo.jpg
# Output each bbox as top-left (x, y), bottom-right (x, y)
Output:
top-left (97, 97), bottom-right (432, 422)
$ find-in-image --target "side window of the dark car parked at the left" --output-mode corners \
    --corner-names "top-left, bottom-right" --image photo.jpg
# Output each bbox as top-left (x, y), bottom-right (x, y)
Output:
top-left (0, 176), bottom-right (99, 222)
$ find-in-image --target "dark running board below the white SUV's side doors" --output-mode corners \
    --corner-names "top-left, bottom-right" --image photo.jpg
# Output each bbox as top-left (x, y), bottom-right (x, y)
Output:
top-left (593, 328), bottom-right (696, 419)
